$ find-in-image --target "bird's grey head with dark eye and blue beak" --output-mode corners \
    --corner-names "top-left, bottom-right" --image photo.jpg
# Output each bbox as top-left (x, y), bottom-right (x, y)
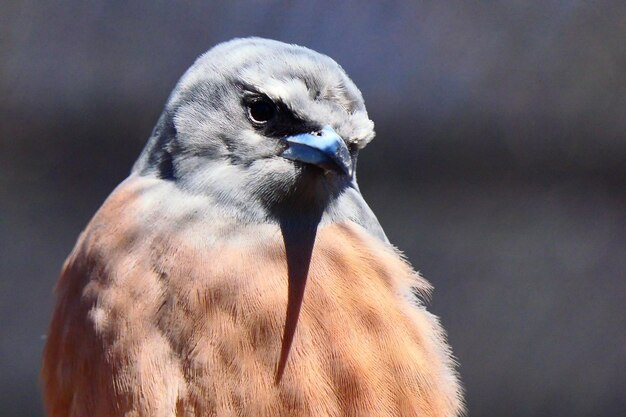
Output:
top-left (135, 38), bottom-right (374, 216)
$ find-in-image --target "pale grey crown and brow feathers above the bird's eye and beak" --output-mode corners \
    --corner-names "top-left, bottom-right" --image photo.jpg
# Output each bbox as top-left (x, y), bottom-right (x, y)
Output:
top-left (168, 38), bottom-right (374, 148)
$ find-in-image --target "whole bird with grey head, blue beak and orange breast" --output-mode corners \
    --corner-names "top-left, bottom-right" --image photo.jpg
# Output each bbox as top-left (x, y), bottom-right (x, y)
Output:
top-left (41, 37), bottom-right (464, 417)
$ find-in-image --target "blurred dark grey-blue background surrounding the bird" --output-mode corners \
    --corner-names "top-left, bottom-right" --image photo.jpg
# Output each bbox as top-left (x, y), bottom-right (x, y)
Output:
top-left (0, 0), bottom-right (626, 417)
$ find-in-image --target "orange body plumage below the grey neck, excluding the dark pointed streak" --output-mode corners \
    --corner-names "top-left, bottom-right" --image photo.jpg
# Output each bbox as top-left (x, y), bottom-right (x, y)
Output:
top-left (43, 176), bottom-right (461, 417)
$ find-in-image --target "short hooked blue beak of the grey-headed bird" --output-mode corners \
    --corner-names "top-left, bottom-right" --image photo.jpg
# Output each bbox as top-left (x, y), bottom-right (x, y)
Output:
top-left (282, 126), bottom-right (352, 176)
